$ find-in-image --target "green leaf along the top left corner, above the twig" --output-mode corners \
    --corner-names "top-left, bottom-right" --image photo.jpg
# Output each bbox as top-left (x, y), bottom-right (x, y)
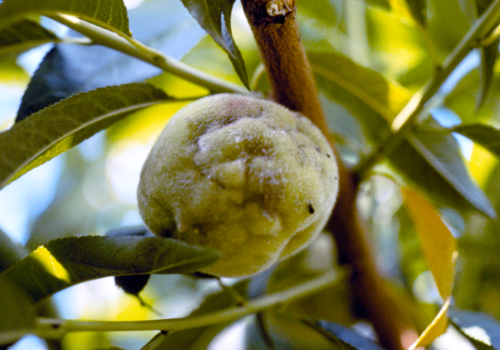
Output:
top-left (0, 0), bottom-right (132, 36)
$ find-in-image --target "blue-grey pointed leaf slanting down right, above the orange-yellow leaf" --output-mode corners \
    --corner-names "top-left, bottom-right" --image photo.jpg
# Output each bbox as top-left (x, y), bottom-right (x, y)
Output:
top-left (407, 122), bottom-right (496, 218)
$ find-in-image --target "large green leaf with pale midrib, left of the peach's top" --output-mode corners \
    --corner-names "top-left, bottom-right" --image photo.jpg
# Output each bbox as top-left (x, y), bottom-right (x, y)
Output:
top-left (0, 83), bottom-right (172, 188)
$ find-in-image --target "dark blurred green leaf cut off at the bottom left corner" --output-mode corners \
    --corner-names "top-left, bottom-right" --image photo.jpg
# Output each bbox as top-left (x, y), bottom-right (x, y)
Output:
top-left (0, 275), bottom-right (35, 345)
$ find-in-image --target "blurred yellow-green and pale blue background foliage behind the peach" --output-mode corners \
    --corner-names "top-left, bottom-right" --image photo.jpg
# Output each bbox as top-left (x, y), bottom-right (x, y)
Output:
top-left (0, 0), bottom-right (500, 349)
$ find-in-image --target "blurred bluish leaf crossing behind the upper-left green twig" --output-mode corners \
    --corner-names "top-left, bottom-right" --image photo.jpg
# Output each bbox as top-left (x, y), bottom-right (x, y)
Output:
top-left (16, 0), bottom-right (205, 122)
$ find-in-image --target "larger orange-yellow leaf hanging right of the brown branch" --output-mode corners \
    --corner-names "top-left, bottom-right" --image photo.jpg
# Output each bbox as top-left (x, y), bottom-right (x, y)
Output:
top-left (401, 187), bottom-right (457, 300)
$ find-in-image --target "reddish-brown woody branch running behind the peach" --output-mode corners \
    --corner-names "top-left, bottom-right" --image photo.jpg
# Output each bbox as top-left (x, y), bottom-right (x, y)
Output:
top-left (242, 0), bottom-right (403, 350)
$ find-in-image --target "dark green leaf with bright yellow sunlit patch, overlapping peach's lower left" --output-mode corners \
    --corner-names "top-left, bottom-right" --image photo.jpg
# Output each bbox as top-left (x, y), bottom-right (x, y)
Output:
top-left (1, 236), bottom-right (220, 301)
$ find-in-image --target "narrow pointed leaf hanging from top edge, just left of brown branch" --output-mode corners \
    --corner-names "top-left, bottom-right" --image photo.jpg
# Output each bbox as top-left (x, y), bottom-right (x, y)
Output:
top-left (182, 0), bottom-right (250, 88)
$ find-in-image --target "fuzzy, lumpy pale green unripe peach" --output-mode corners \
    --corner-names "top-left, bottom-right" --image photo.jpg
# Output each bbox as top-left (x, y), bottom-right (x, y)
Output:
top-left (138, 94), bottom-right (338, 277)
